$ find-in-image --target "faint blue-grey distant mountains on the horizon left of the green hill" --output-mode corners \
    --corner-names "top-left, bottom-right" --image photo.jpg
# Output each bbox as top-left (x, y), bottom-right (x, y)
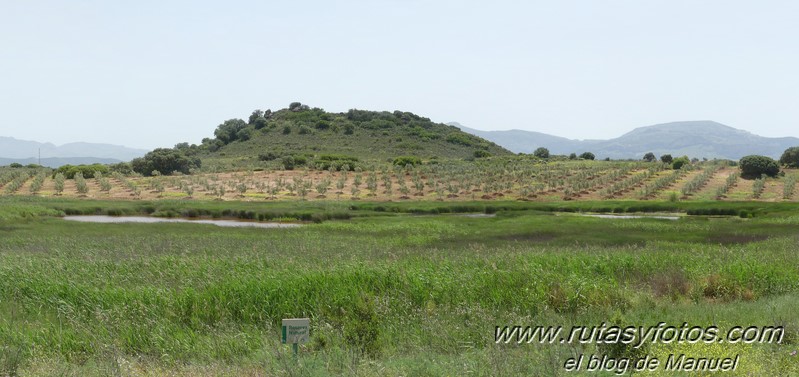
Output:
top-left (0, 136), bottom-right (148, 167)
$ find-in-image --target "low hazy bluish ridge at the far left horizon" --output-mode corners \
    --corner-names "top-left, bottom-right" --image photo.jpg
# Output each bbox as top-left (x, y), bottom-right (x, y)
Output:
top-left (0, 136), bottom-right (147, 163)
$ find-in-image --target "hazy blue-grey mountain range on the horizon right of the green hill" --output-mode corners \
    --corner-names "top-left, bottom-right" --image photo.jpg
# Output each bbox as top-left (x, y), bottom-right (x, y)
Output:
top-left (448, 120), bottom-right (799, 160)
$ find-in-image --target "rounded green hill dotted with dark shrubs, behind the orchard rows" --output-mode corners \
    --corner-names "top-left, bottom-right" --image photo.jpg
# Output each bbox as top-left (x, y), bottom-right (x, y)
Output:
top-left (198, 104), bottom-right (511, 165)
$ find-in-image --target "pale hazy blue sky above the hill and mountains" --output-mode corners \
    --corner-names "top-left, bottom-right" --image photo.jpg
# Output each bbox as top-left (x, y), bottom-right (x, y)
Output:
top-left (0, 0), bottom-right (799, 148)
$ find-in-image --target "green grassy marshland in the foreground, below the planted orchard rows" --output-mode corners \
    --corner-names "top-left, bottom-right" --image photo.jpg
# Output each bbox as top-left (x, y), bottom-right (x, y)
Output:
top-left (0, 199), bottom-right (799, 376)
